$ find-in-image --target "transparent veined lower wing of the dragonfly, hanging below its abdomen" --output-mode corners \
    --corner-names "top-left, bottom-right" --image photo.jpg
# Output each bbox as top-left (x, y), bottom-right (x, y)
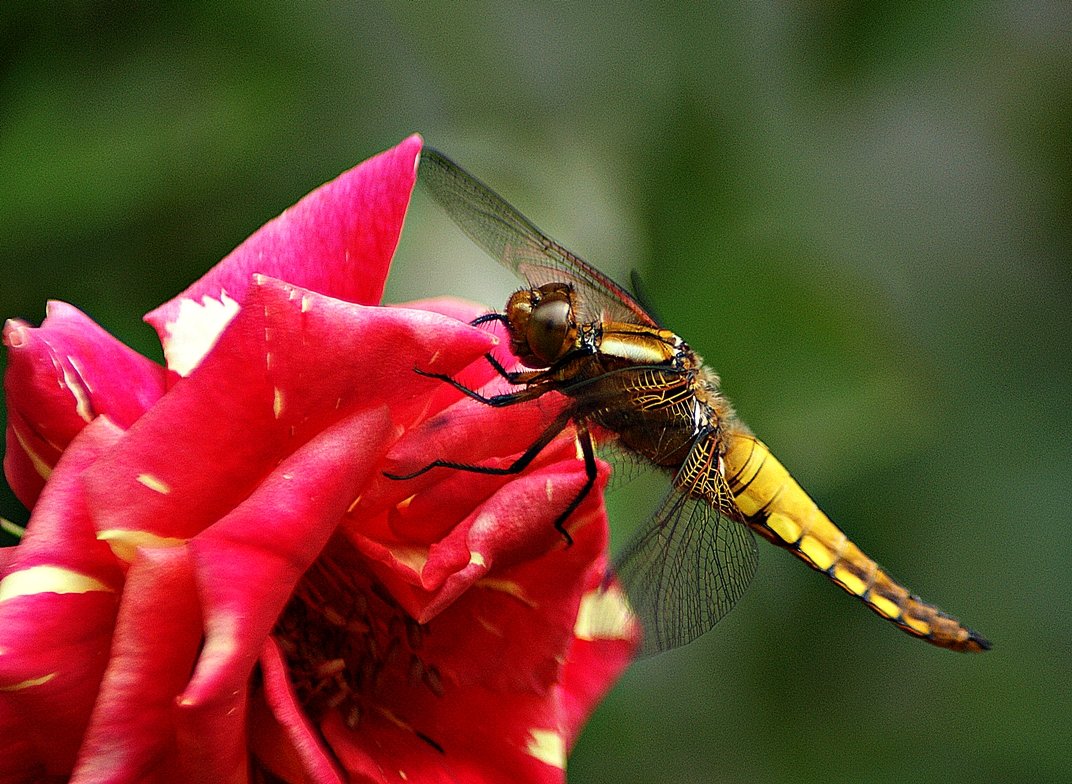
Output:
top-left (614, 442), bottom-right (759, 656)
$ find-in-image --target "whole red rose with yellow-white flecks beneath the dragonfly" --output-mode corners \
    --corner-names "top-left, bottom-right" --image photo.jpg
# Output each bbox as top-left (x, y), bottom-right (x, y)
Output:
top-left (0, 136), bottom-right (636, 782)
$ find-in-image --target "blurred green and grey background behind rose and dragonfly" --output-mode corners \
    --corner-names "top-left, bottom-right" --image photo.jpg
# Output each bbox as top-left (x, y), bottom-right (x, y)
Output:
top-left (0, 0), bottom-right (1072, 784)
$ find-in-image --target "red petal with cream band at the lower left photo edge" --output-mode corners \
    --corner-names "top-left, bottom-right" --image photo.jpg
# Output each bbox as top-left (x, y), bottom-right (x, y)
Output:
top-left (0, 417), bottom-right (122, 775)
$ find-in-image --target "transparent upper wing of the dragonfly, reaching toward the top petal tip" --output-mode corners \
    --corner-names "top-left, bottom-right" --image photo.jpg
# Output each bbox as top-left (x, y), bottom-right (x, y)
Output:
top-left (418, 147), bottom-right (657, 326)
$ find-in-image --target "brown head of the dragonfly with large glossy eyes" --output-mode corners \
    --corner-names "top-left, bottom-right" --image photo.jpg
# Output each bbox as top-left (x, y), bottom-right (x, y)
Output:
top-left (506, 283), bottom-right (578, 368)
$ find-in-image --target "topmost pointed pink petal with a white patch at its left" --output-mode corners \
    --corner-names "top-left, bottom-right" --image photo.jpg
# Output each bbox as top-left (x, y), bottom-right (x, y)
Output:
top-left (146, 135), bottom-right (421, 375)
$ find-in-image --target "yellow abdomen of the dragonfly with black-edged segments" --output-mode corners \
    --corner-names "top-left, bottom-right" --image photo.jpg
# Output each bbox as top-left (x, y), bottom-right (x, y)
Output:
top-left (724, 433), bottom-right (991, 651)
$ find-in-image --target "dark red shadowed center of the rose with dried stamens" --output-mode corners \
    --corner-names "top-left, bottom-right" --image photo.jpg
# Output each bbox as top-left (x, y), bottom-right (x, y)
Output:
top-left (272, 534), bottom-right (444, 728)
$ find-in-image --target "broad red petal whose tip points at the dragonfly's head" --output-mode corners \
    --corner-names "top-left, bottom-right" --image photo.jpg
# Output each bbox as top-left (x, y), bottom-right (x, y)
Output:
top-left (87, 278), bottom-right (491, 551)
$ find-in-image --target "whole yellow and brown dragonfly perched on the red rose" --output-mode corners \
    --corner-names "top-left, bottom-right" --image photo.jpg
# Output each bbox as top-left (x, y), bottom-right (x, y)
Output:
top-left (390, 148), bottom-right (991, 656)
